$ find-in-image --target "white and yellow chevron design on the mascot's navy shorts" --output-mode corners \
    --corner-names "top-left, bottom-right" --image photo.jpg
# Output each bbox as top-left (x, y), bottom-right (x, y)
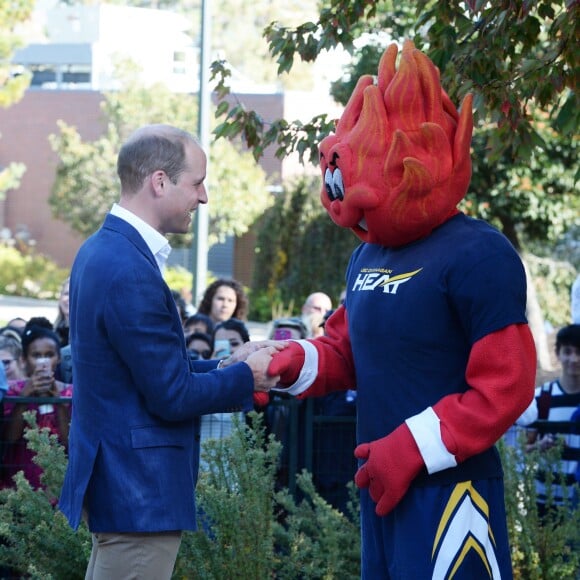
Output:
top-left (431, 481), bottom-right (500, 580)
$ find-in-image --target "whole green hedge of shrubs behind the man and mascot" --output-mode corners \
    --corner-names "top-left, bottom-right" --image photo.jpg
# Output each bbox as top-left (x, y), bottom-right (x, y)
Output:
top-left (0, 413), bottom-right (580, 580)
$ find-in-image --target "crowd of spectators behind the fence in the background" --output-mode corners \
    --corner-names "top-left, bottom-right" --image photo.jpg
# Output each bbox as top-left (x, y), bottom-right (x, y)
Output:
top-left (0, 278), bottom-right (580, 510)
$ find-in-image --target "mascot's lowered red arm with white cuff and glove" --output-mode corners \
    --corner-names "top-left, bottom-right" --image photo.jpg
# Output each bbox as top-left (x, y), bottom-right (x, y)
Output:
top-left (355, 324), bottom-right (536, 516)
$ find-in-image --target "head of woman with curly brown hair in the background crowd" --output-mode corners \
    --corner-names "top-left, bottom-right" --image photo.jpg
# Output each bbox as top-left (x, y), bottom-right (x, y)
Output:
top-left (197, 278), bottom-right (248, 324)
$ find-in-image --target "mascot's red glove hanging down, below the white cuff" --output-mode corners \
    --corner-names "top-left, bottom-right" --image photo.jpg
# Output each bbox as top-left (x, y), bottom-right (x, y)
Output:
top-left (354, 423), bottom-right (424, 516)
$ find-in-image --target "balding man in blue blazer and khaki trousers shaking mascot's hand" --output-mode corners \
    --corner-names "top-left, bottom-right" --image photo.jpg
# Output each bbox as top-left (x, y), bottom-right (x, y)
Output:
top-left (59, 125), bottom-right (282, 580)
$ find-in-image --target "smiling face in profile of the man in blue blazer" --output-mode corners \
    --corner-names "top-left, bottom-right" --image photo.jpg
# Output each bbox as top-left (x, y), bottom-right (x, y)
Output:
top-left (160, 143), bottom-right (207, 234)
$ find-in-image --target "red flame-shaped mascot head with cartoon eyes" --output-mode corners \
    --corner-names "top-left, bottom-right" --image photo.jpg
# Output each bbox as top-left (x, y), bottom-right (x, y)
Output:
top-left (319, 41), bottom-right (473, 246)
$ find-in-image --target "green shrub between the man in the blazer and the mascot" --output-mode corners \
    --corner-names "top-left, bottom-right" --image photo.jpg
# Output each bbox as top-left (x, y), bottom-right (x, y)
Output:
top-left (175, 413), bottom-right (360, 580)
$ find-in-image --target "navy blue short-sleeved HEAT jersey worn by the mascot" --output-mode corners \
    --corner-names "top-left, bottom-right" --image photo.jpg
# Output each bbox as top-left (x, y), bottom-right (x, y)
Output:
top-left (346, 214), bottom-right (526, 483)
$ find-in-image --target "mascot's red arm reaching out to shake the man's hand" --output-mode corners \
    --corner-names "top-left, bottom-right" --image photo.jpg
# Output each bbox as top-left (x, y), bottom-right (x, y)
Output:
top-left (268, 306), bottom-right (356, 397)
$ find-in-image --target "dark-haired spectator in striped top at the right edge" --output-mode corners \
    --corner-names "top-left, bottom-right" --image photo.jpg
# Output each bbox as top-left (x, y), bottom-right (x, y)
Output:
top-left (528, 324), bottom-right (580, 513)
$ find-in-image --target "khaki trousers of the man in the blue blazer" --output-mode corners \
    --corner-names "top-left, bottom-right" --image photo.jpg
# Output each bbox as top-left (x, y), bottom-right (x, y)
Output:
top-left (85, 532), bottom-right (181, 580)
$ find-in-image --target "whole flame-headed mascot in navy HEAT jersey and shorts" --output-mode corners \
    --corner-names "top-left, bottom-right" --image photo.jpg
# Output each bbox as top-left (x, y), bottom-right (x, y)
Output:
top-left (269, 41), bottom-right (536, 580)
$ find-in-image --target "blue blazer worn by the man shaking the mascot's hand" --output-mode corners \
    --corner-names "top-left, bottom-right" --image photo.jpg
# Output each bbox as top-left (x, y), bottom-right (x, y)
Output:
top-left (59, 215), bottom-right (254, 532)
